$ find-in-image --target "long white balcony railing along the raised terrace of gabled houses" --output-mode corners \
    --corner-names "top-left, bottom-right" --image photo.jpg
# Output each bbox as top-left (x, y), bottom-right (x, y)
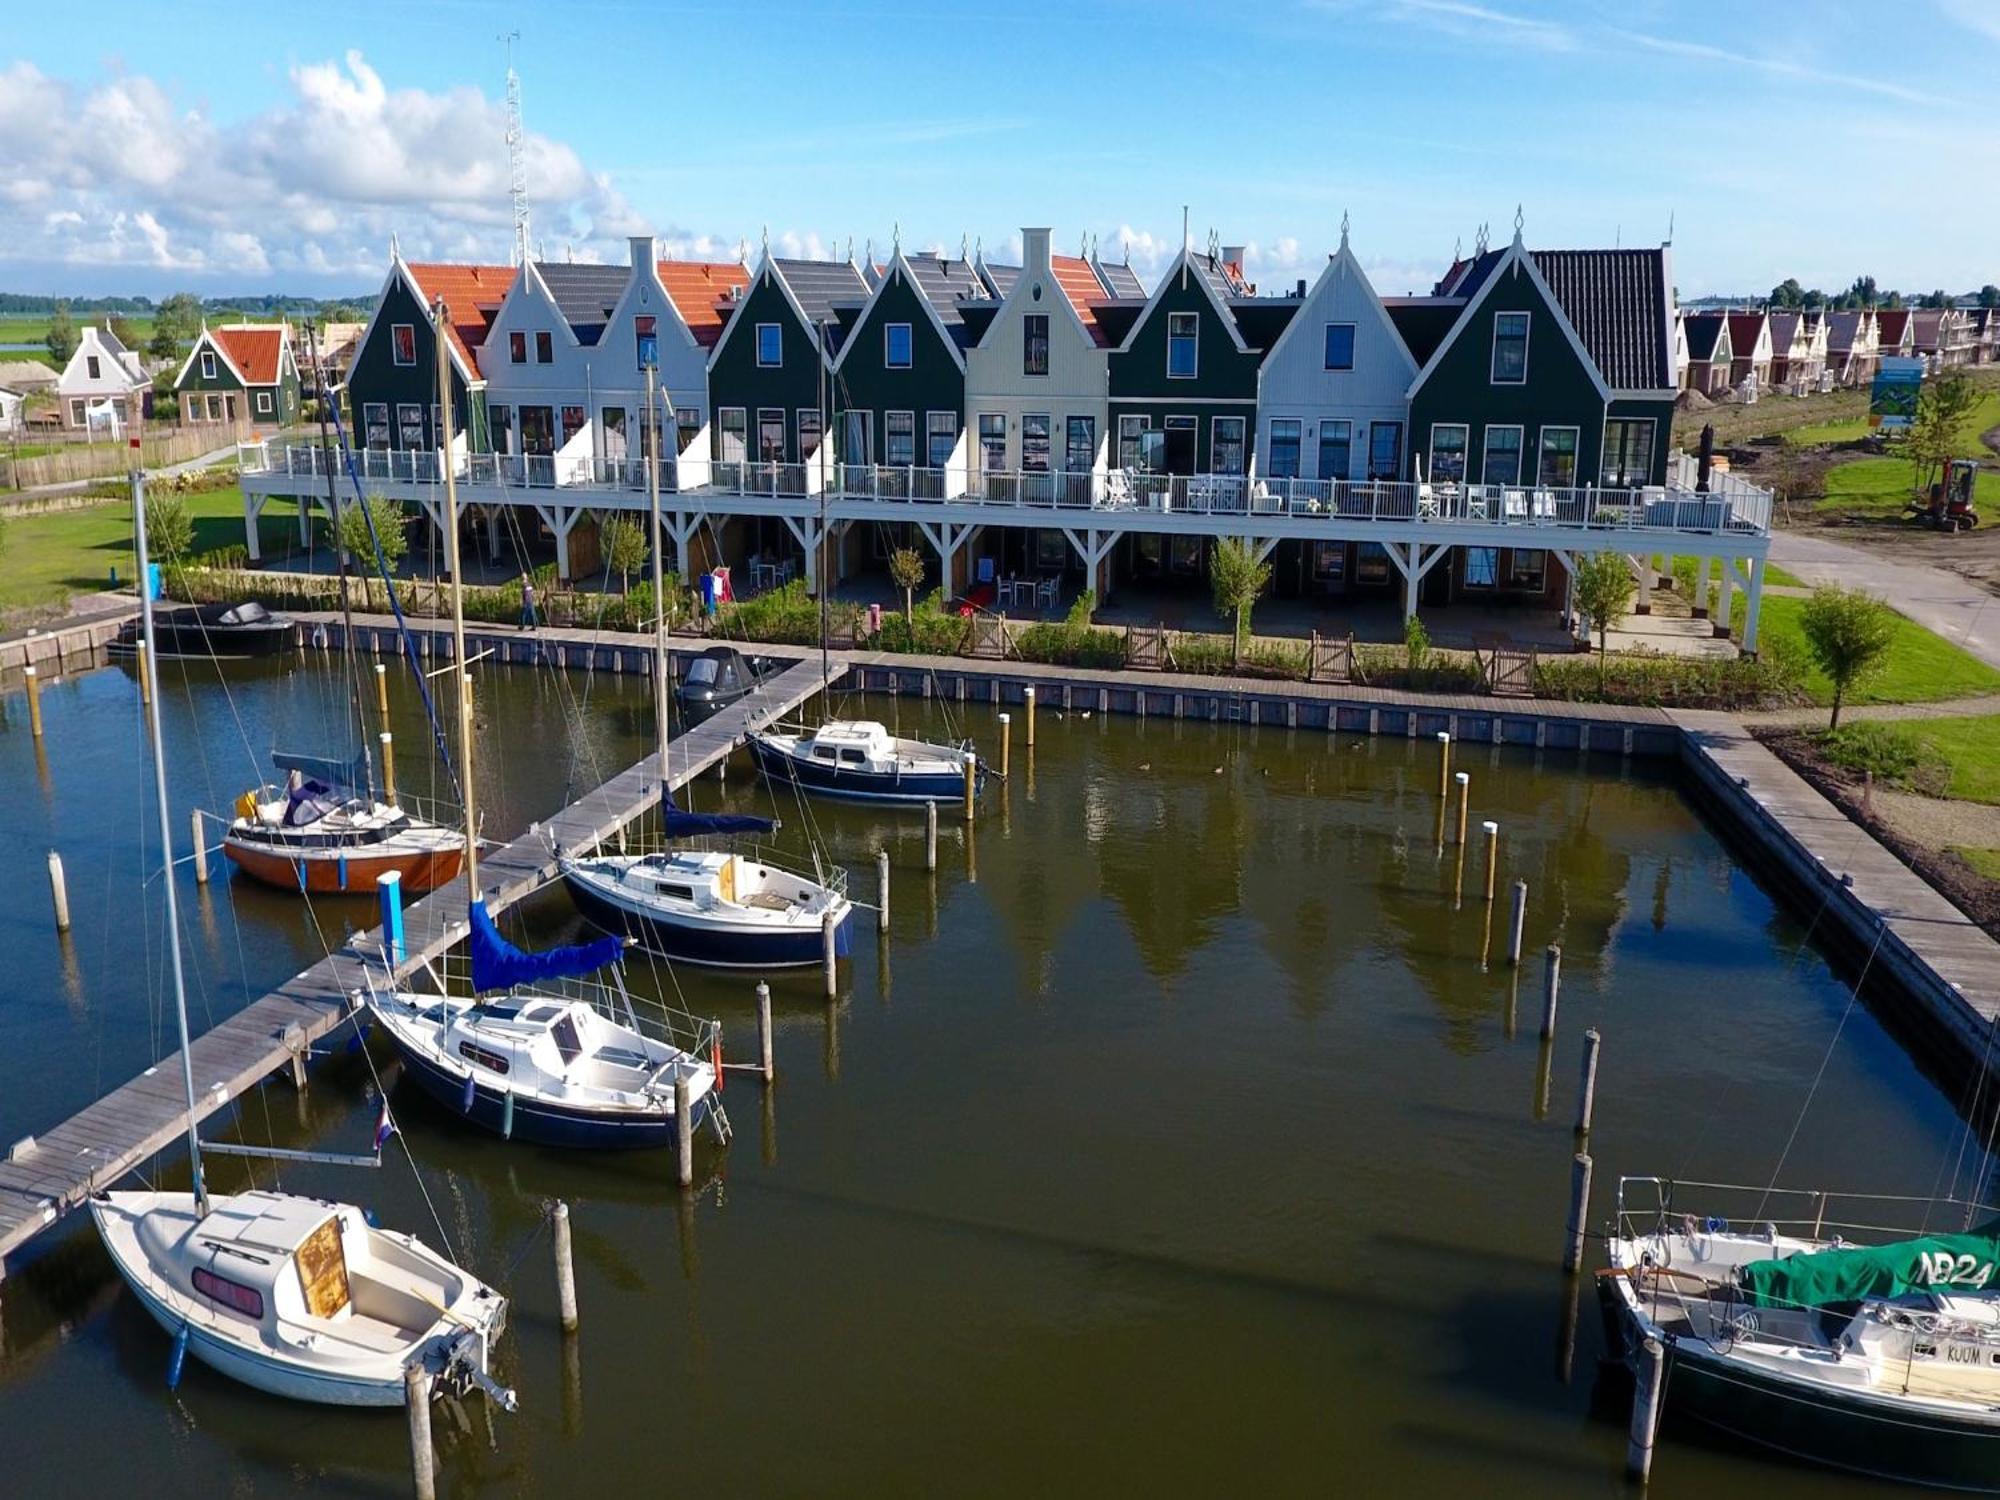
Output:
top-left (242, 444), bottom-right (1772, 534)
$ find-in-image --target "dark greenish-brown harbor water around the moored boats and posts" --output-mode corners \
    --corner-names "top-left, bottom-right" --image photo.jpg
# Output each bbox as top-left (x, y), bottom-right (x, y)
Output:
top-left (0, 656), bottom-right (1964, 1500)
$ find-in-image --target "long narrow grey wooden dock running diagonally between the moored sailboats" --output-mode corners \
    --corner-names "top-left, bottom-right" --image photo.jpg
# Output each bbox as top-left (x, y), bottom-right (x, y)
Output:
top-left (0, 660), bottom-right (846, 1270)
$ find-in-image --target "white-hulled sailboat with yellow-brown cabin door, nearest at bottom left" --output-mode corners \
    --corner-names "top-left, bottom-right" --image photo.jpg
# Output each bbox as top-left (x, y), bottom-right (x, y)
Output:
top-left (90, 470), bottom-right (514, 1410)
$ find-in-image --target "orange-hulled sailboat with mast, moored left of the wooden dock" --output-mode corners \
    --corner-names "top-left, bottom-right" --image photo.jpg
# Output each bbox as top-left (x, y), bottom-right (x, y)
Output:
top-left (222, 320), bottom-right (466, 896)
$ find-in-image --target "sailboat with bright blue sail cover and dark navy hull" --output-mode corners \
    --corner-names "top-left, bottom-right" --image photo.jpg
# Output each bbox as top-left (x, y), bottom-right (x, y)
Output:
top-left (368, 302), bottom-right (728, 1148)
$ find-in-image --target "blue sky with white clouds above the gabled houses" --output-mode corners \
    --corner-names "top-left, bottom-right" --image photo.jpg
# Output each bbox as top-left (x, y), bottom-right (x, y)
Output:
top-left (0, 0), bottom-right (2000, 298)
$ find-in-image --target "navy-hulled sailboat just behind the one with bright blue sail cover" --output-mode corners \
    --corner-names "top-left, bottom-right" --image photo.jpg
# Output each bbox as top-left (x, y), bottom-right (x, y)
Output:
top-left (558, 364), bottom-right (854, 968)
